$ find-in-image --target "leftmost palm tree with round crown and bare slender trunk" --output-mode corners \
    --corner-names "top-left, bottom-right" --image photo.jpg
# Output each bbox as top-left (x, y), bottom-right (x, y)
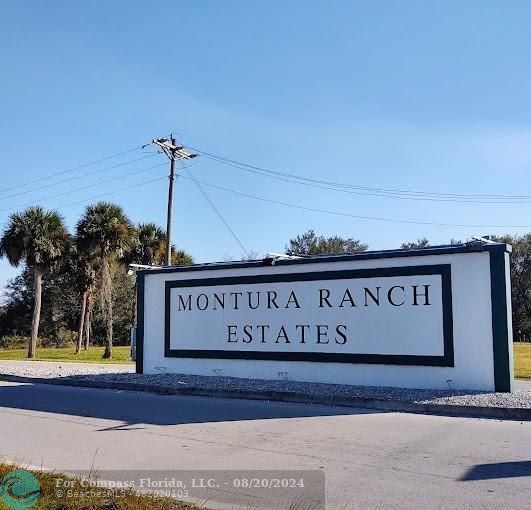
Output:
top-left (0, 207), bottom-right (69, 358)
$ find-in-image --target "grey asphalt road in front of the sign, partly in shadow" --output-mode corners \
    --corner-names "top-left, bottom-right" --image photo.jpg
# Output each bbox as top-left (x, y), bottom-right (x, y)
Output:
top-left (0, 382), bottom-right (531, 510)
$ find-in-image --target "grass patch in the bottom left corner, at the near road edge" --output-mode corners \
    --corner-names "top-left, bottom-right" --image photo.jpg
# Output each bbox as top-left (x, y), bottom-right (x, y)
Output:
top-left (0, 464), bottom-right (200, 510)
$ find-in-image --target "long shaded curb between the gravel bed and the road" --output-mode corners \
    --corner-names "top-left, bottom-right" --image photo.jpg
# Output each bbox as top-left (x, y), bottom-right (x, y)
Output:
top-left (0, 374), bottom-right (531, 421)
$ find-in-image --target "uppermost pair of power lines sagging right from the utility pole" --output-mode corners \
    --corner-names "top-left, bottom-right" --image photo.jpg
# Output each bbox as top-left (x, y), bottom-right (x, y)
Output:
top-left (189, 147), bottom-right (531, 204)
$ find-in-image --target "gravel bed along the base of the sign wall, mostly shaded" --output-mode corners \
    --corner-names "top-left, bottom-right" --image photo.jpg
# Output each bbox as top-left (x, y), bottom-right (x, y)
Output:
top-left (0, 361), bottom-right (531, 409)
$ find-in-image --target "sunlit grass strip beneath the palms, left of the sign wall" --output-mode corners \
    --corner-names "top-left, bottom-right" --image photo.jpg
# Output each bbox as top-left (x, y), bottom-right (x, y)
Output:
top-left (0, 345), bottom-right (132, 363)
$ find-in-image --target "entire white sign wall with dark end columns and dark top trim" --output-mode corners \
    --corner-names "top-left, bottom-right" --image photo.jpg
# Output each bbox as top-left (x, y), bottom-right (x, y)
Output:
top-left (137, 244), bottom-right (512, 391)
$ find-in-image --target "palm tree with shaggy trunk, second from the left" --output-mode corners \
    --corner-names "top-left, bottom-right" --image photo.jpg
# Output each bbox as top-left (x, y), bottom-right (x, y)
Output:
top-left (76, 202), bottom-right (132, 358)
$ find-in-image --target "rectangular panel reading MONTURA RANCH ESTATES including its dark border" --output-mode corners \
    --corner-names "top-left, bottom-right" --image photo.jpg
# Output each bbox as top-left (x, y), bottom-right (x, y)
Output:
top-left (165, 265), bottom-right (453, 366)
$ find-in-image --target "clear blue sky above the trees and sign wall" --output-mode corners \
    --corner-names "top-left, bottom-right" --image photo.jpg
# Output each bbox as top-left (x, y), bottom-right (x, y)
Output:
top-left (0, 0), bottom-right (531, 284)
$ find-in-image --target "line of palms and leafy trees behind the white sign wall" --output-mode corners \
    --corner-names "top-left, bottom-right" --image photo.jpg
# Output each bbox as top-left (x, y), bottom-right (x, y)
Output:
top-left (0, 211), bottom-right (531, 358)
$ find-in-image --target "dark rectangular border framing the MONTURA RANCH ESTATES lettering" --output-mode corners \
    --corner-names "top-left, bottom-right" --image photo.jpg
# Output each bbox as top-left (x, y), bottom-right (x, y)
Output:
top-left (164, 264), bottom-right (454, 367)
